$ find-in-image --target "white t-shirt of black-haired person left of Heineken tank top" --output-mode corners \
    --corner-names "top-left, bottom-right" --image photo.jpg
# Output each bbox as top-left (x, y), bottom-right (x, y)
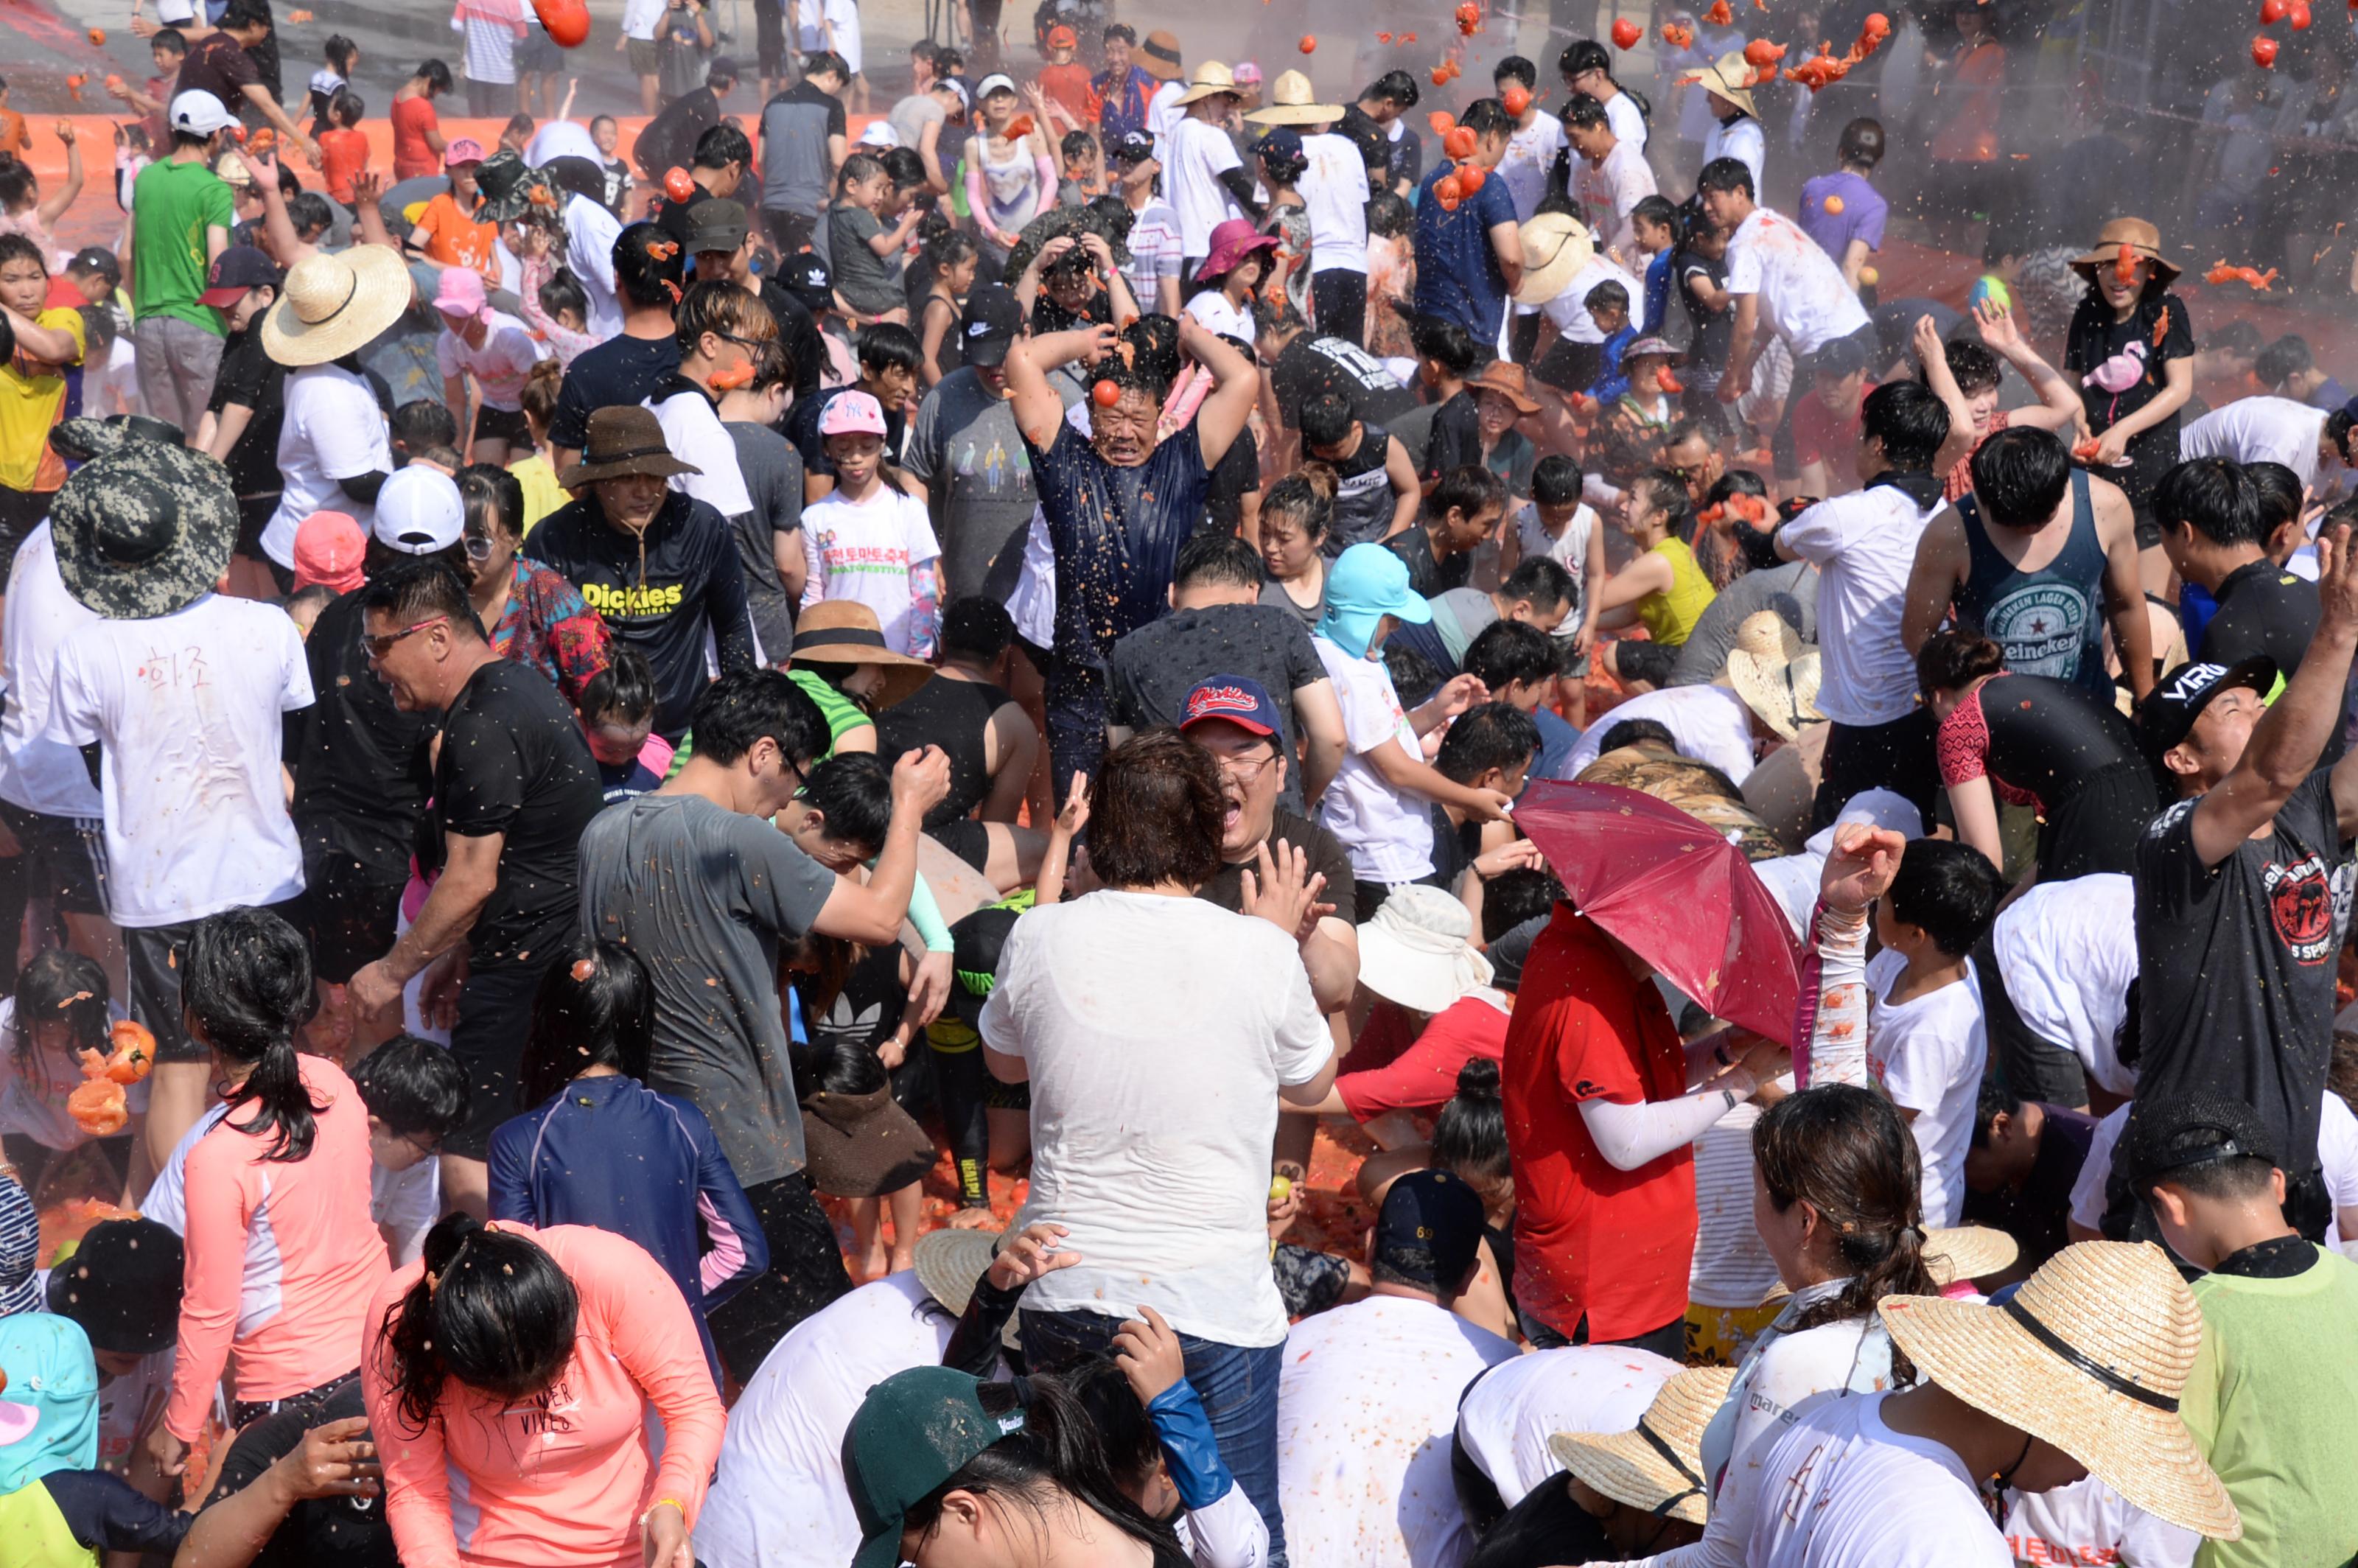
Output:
top-left (1778, 486), bottom-right (1948, 727)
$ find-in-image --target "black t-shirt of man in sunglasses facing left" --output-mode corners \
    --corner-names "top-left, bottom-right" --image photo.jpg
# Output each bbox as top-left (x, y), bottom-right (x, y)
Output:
top-left (420, 658), bottom-right (606, 971)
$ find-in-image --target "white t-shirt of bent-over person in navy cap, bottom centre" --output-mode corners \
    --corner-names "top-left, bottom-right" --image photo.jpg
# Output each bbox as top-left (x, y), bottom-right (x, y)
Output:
top-left (1282, 1292), bottom-right (1516, 1568)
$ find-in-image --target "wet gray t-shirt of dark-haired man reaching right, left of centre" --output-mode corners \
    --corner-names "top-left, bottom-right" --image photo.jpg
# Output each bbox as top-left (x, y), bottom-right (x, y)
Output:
top-left (580, 794), bottom-right (835, 1186)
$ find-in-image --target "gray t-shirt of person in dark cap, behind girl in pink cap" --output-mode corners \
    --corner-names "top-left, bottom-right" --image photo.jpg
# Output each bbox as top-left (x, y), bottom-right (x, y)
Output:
top-left (908, 370), bottom-right (1080, 603)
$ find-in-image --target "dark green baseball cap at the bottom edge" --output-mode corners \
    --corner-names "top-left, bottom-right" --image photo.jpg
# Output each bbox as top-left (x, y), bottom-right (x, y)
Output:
top-left (844, 1368), bottom-right (1024, 1568)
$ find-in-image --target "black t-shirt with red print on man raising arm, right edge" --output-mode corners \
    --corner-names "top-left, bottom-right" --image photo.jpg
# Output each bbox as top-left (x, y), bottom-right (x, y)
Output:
top-left (2134, 769), bottom-right (2348, 1177)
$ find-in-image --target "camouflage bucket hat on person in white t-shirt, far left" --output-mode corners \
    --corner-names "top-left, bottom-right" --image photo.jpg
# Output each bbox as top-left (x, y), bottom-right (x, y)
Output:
top-left (49, 441), bottom-right (238, 620)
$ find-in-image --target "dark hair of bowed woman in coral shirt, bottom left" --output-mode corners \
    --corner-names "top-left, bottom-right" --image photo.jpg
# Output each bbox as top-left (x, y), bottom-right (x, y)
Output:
top-left (375, 1212), bottom-right (580, 1434)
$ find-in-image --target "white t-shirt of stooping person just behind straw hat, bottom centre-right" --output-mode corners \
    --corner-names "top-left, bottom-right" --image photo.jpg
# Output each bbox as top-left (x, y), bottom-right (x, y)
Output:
top-left (1458, 1344), bottom-right (1679, 1509)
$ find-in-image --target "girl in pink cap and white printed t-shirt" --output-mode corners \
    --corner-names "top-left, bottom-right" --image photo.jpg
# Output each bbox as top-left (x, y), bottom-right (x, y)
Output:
top-left (802, 391), bottom-right (941, 658)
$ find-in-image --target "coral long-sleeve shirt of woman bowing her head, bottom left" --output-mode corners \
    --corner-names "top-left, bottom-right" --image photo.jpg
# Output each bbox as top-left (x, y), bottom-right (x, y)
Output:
top-left (361, 1222), bottom-right (727, 1568)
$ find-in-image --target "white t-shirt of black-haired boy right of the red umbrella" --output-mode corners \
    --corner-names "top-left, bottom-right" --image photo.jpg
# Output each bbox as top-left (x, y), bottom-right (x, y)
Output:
top-left (1867, 948), bottom-right (1990, 1226)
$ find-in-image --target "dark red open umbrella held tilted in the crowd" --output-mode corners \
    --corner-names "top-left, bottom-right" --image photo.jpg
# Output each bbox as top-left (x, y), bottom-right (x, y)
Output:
top-left (1514, 783), bottom-right (1802, 1045)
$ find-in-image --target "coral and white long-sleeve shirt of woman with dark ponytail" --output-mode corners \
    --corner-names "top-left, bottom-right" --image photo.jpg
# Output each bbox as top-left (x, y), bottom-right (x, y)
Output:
top-left (163, 1057), bottom-right (389, 1443)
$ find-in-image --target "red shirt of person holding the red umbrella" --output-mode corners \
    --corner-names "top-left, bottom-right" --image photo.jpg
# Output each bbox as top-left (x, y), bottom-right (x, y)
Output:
top-left (1500, 903), bottom-right (1696, 1342)
